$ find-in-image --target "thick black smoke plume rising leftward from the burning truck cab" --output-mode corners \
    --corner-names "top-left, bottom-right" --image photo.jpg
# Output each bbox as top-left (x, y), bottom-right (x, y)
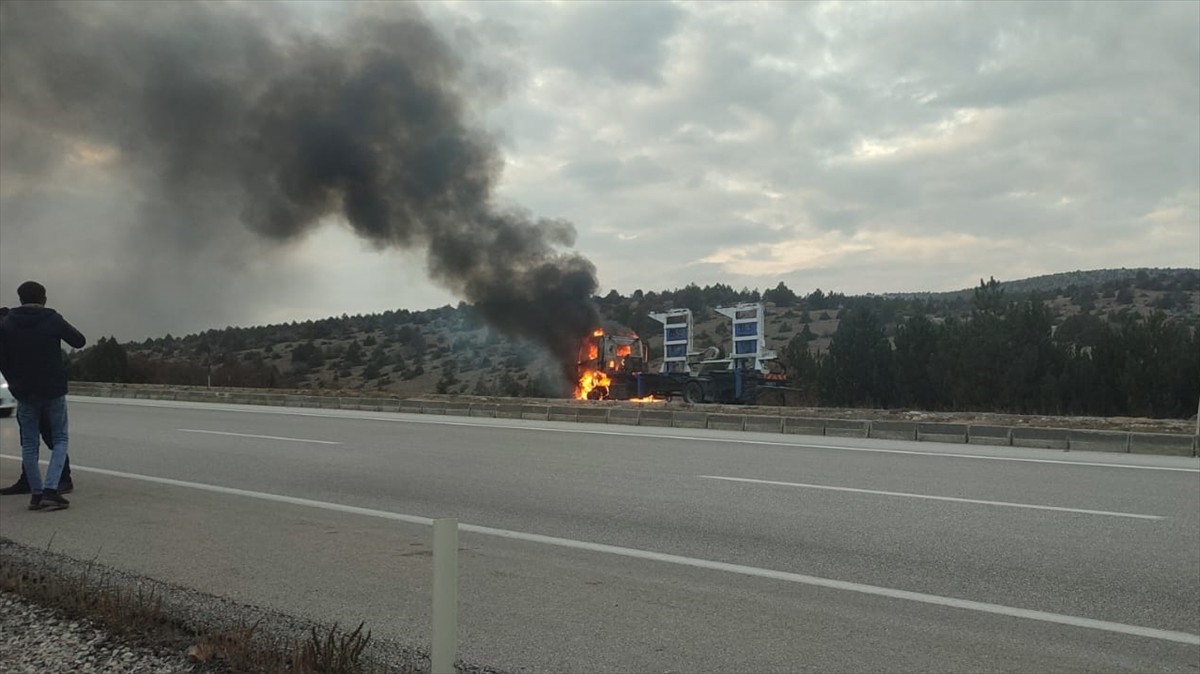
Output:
top-left (0, 1), bottom-right (599, 377)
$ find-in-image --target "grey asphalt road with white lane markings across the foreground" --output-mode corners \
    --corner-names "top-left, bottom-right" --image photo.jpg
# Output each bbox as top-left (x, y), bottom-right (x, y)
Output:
top-left (0, 398), bottom-right (1200, 672)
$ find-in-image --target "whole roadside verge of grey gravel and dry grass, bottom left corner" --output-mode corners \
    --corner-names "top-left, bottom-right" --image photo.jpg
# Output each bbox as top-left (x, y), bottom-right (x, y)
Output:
top-left (0, 537), bottom-right (505, 674)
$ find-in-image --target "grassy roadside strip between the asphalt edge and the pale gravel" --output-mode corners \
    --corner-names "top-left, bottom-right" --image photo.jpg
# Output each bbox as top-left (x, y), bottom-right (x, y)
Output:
top-left (0, 538), bottom-right (408, 674)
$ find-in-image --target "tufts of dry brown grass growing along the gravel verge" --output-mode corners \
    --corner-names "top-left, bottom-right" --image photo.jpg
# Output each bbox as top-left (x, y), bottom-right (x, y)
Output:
top-left (0, 546), bottom-right (380, 674)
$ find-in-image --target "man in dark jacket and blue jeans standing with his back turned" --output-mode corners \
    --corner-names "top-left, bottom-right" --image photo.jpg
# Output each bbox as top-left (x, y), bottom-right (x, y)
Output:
top-left (0, 281), bottom-right (86, 510)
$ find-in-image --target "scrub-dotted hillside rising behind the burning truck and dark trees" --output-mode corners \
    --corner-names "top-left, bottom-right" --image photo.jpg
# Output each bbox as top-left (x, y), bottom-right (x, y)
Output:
top-left (73, 270), bottom-right (1200, 411)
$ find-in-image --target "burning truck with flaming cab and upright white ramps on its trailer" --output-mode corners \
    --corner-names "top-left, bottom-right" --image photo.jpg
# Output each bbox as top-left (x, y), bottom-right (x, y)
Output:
top-left (575, 303), bottom-right (790, 404)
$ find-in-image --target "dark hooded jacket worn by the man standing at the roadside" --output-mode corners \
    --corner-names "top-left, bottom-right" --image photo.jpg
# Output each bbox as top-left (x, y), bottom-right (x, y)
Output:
top-left (0, 305), bottom-right (86, 401)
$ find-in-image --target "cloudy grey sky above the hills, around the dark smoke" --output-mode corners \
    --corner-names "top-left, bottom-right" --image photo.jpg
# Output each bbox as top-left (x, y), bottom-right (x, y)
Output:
top-left (0, 1), bottom-right (1200, 339)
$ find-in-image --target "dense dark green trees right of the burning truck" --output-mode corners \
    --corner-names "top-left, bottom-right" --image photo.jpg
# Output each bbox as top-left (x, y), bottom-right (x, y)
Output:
top-left (782, 281), bottom-right (1200, 419)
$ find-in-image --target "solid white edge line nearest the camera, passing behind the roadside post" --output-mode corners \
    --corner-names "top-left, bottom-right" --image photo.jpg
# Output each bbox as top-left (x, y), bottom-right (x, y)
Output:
top-left (0, 455), bottom-right (1200, 645)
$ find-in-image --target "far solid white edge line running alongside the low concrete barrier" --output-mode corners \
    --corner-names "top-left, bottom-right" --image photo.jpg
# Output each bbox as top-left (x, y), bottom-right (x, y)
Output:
top-left (72, 398), bottom-right (1200, 473)
